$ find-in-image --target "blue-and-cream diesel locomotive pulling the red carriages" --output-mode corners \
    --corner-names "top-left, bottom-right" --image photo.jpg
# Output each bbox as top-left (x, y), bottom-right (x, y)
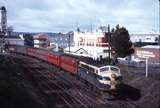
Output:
top-left (78, 61), bottom-right (122, 91)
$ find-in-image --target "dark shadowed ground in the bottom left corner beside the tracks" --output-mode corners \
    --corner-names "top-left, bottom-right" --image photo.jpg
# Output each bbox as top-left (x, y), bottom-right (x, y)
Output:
top-left (0, 55), bottom-right (47, 108)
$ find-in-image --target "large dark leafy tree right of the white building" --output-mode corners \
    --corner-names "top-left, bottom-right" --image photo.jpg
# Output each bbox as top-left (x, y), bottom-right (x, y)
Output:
top-left (111, 25), bottom-right (134, 59)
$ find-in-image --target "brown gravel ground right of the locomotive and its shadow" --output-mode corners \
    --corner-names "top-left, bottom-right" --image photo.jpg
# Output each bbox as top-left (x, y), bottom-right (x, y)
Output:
top-left (119, 66), bottom-right (160, 108)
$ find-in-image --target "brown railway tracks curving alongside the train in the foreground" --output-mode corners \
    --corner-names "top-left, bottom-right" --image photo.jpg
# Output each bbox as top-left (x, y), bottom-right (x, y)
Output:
top-left (5, 54), bottom-right (145, 108)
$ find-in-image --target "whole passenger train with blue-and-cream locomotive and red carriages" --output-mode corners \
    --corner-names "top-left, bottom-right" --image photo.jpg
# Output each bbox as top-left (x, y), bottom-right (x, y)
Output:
top-left (7, 45), bottom-right (122, 91)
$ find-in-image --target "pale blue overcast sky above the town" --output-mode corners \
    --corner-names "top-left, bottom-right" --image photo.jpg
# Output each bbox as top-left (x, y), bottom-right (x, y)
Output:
top-left (0, 0), bottom-right (159, 33)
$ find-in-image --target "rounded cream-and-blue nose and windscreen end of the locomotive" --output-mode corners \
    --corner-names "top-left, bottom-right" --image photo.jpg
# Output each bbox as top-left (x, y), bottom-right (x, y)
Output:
top-left (97, 66), bottom-right (122, 91)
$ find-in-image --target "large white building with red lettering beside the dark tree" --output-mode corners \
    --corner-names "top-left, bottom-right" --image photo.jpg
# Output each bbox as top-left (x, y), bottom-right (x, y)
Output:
top-left (64, 31), bottom-right (109, 59)
